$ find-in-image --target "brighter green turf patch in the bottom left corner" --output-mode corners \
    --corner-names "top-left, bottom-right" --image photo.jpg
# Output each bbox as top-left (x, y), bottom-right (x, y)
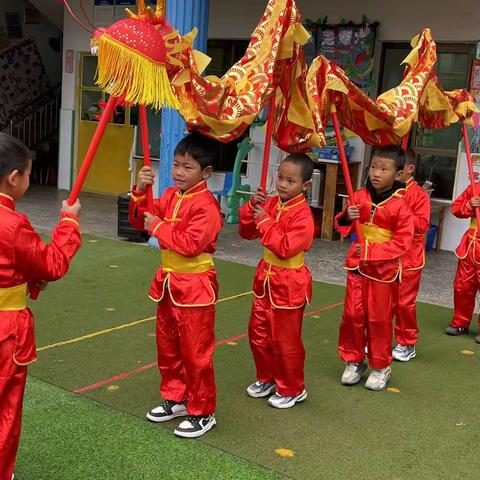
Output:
top-left (15, 378), bottom-right (281, 480)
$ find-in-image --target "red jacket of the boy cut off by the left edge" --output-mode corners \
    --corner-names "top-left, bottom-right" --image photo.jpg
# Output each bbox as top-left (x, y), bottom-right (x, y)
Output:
top-left (0, 194), bottom-right (81, 365)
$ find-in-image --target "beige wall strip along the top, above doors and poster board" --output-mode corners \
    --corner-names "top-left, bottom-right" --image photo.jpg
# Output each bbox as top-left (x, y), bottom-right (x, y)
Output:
top-left (208, 0), bottom-right (480, 42)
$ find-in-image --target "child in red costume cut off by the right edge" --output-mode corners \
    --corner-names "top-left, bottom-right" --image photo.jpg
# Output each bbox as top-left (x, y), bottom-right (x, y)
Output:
top-left (445, 183), bottom-right (480, 343)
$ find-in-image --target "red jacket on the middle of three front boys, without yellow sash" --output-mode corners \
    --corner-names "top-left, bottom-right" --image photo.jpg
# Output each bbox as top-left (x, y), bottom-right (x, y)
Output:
top-left (239, 195), bottom-right (314, 308)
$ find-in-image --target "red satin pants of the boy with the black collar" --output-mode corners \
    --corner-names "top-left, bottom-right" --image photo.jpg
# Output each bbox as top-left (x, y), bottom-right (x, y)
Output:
top-left (338, 272), bottom-right (397, 369)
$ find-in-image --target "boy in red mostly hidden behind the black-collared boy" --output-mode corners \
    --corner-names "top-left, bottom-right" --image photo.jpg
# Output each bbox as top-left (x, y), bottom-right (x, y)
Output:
top-left (392, 149), bottom-right (430, 362)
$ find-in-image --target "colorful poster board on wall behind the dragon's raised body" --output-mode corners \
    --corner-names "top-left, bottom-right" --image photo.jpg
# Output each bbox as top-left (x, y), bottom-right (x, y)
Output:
top-left (317, 23), bottom-right (378, 93)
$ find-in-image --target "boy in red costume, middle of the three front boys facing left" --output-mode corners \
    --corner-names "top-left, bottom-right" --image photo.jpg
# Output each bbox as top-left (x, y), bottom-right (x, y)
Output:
top-left (239, 154), bottom-right (314, 408)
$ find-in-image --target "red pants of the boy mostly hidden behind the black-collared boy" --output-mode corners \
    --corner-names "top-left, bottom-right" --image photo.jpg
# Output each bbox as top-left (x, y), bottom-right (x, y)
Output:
top-left (395, 268), bottom-right (422, 346)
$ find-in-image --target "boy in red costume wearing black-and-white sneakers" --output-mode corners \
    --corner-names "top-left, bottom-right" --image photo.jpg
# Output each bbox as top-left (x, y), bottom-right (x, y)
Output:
top-left (129, 133), bottom-right (222, 438)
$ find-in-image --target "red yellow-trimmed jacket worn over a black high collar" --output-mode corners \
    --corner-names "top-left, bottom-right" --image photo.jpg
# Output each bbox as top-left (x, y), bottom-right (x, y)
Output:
top-left (334, 184), bottom-right (414, 282)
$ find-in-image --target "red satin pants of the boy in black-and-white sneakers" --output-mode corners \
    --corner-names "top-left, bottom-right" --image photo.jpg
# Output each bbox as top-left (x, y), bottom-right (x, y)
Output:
top-left (157, 291), bottom-right (216, 415)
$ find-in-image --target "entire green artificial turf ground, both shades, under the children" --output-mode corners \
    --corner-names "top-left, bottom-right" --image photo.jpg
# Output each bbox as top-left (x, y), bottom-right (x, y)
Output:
top-left (17, 237), bottom-right (480, 480)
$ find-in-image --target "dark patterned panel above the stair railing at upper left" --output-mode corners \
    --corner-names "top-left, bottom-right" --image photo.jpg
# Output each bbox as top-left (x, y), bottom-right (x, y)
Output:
top-left (0, 38), bottom-right (50, 129)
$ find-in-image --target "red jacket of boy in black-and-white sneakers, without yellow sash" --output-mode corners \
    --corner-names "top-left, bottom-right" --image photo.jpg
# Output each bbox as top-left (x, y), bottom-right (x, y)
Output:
top-left (129, 182), bottom-right (222, 306)
